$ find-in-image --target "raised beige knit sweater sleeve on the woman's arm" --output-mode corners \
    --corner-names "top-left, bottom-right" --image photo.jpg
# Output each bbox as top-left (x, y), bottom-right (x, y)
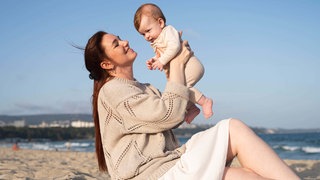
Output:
top-left (104, 82), bottom-right (189, 133)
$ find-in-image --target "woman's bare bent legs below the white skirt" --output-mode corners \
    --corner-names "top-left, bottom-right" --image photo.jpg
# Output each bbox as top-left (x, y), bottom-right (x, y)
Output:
top-left (224, 119), bottom-right (299, 180)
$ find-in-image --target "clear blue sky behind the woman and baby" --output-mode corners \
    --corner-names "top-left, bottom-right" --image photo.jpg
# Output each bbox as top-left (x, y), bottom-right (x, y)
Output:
top-left (0, 0), bottom-right (320, 129)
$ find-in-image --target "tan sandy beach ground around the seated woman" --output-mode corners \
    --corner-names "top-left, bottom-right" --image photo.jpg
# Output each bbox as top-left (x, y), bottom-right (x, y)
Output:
top-left (0, 148), bottom-right (320, 180)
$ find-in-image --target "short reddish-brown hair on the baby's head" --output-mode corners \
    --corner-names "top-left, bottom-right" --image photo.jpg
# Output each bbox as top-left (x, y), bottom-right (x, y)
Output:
top-left (133, 3), bottom-right (166, 31)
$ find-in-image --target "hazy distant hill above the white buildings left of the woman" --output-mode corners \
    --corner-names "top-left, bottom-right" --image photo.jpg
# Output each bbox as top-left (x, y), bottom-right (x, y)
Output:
top-left (0, 114), bottom-right (93, 125)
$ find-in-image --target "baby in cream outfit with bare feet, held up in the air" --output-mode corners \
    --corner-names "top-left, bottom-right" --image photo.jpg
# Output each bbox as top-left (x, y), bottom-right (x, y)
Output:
top-left (134, 3), bottom-right (213, 123)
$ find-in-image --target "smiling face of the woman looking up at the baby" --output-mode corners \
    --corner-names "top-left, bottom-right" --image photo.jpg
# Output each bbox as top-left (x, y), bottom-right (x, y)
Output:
top-left (101, 34), bottom-right (137, 67)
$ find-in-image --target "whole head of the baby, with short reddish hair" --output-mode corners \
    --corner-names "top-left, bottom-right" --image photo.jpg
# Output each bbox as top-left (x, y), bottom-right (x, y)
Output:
top-left (134, 3), bottom-right (166, 42)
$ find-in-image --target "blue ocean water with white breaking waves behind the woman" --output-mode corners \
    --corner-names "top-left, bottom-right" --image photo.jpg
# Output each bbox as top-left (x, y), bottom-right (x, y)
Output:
top-left (0, 132), bottom-right (320, 160)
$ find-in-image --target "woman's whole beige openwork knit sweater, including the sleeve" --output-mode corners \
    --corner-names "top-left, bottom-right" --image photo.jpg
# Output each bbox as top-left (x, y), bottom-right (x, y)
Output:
top-left (98, 78), bottom-right (189, 179)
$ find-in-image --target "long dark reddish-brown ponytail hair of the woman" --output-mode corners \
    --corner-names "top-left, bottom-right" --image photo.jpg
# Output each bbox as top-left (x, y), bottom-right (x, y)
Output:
top-left (84, 31), bottom-right (111, 171)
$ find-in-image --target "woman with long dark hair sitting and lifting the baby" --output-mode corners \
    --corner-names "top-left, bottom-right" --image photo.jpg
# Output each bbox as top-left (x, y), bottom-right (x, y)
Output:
top-left (85, 31), bottom-right (298, 179)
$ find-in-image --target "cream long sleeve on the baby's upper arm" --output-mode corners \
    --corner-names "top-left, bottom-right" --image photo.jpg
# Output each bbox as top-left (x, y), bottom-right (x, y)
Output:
top-left (159, 25), bottom-right (181, 65)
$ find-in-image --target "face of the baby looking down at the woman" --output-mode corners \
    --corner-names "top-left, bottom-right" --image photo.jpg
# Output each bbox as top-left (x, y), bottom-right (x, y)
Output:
top-left (138, 15), bottom-right (164, 43)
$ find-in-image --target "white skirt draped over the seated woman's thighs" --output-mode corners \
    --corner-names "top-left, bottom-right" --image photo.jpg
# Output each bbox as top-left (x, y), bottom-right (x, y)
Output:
top-left (159, 119), bottom-right (230, 180)
